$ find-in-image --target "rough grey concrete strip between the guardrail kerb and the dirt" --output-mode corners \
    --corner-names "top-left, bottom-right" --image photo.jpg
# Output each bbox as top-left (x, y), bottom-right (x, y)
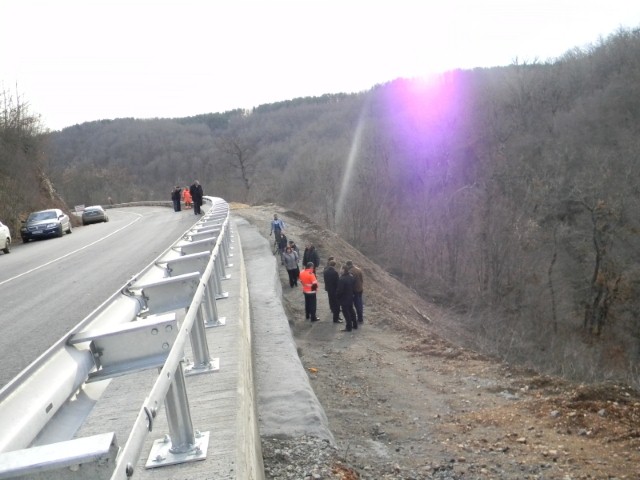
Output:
top-left (232, 214), bottom-right (335, 444)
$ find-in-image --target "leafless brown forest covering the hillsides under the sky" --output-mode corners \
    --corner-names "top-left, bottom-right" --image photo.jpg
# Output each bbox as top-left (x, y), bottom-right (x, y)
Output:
top-left (0, 29), bottom-right (640, 386)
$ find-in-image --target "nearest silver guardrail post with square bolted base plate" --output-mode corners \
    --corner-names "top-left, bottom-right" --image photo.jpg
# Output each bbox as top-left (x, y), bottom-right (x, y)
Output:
top-left (145, 362), bottom-right (209, 468)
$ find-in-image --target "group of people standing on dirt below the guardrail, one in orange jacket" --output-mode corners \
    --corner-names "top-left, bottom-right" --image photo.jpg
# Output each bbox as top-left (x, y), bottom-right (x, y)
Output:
top-left (269, 214), bottom-right (364, 332)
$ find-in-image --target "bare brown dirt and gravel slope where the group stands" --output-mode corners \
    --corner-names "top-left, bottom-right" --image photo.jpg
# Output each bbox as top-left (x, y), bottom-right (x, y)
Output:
top-left (232, 205), bottom-right (640, 480)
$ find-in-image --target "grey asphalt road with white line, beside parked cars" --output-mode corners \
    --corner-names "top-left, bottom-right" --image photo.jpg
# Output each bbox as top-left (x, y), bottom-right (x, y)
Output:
top-left (0, 207), bottom-right (200, 388)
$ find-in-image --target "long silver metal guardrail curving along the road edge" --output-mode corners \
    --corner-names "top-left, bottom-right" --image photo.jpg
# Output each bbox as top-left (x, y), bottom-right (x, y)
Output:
top-left (0, 197), bottom-right (232, 480)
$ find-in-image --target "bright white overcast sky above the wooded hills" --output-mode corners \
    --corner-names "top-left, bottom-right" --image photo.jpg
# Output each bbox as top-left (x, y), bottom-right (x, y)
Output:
top-left (0, 0), bottom-right (640, 130)
